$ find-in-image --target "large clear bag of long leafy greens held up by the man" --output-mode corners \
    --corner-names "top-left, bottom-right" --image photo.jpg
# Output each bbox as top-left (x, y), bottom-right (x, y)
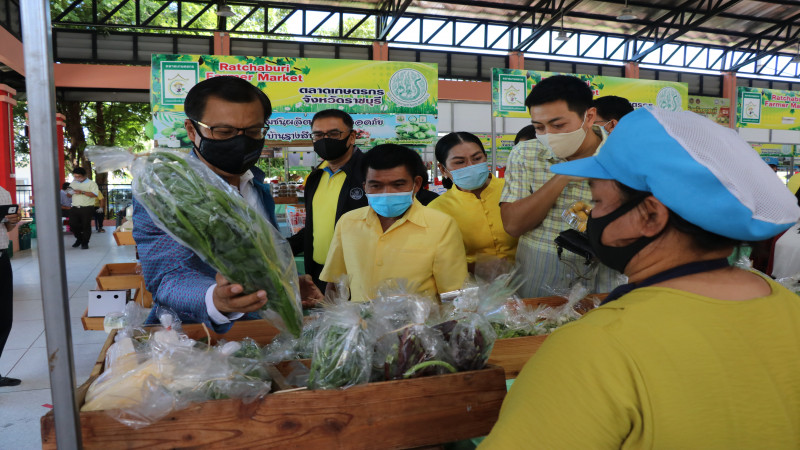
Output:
top-left (86, 147), bottom-right (303, 336)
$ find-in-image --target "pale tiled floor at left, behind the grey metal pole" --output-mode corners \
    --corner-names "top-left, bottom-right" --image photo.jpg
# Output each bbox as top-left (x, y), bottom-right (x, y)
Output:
top-left (0, 232), bottom-right (135, 450)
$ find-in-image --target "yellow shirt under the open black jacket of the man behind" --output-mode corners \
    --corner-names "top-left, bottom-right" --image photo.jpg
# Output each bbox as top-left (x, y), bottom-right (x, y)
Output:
top-left (311, 169), bottom-right (347, 264)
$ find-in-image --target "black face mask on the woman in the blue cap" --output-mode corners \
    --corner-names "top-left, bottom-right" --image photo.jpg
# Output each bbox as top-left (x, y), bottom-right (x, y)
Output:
top-left (586, 193), bottom-right (663, 272)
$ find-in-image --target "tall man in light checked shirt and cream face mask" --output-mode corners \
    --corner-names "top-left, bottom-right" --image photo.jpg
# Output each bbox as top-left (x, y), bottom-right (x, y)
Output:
top-left (500, 75), bottom-right (619, 297)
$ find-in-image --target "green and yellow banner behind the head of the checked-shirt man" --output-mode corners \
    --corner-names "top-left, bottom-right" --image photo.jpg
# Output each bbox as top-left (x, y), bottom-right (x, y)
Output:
top-left (492, 68), bottom-right (689, 118)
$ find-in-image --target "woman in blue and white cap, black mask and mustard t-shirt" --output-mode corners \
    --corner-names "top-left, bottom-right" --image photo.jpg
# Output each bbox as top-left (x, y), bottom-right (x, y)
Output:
top-left (481, 107), bottom-right (800, 449)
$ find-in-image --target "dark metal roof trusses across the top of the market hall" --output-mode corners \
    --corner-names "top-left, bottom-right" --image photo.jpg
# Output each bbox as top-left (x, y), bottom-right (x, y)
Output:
top-left (0, 0), bottom-right (800, 93)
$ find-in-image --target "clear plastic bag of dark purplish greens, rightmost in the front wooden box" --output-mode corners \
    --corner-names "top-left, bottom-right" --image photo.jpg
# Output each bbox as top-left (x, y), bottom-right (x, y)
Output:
top-left (434, 313), bottom-right (497, 371)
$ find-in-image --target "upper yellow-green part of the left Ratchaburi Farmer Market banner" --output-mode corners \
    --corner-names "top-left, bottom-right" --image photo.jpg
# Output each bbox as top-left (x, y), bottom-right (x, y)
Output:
top-left (150, 54), bottom-right (439, 114)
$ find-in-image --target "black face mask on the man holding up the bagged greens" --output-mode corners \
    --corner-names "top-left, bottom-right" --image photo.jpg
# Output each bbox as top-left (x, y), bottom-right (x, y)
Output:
top-left (192, 133), bottom-right (264, 175)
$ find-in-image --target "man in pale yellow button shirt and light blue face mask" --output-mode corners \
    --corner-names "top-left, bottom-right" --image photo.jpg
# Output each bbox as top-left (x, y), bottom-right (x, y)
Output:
top-left (320, 144), bottom-right (467, 301)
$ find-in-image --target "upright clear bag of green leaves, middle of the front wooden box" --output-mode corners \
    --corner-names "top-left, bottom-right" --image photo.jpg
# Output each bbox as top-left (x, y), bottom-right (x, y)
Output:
top-left (308, 302), bottom-right (375, 389)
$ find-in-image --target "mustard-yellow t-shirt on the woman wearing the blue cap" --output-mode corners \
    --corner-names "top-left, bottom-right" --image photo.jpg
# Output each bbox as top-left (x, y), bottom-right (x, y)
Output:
top-left (481, 280), bottom-right (800, 450)
